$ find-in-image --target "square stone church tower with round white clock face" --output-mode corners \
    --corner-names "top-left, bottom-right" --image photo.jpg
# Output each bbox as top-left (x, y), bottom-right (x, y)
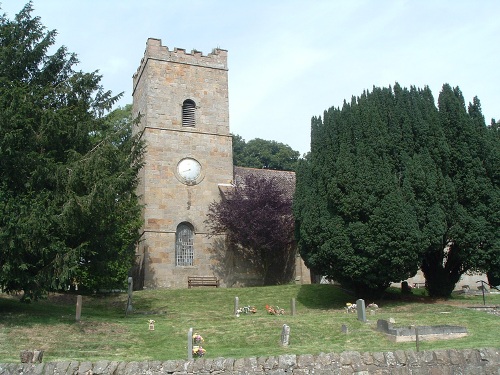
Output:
top-left (132, 39), bottom-right (233, 288)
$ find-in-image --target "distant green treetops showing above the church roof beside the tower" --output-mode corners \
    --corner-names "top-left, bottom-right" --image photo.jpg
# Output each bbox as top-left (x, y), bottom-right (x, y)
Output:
top-left (233, 134), bottom-right (300, 171)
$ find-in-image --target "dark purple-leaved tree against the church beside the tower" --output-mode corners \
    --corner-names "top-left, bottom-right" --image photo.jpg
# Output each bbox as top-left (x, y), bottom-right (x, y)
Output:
top-left (205, 174), bottom-right (295, 285)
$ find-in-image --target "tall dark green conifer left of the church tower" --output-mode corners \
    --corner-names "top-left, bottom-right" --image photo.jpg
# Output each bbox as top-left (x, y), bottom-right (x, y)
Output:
top-left (0, 3), bottom-right (143, 300)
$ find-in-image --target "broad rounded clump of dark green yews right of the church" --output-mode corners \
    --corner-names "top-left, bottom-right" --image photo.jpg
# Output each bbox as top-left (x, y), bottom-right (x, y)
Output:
top-left (294, 84), bottom-right (500, 297)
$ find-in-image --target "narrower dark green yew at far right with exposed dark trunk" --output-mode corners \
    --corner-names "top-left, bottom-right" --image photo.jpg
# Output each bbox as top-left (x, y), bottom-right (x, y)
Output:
top-left (422, 85), bottom-right (500, 296)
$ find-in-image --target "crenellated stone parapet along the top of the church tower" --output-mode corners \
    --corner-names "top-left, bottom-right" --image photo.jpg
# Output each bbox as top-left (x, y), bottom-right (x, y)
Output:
top-left (133, 38), bottom-right (228, 91)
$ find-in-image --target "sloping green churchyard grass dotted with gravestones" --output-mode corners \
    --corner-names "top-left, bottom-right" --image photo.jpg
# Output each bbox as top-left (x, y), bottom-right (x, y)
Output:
top-left (0, 285), bottom-right (500, 362)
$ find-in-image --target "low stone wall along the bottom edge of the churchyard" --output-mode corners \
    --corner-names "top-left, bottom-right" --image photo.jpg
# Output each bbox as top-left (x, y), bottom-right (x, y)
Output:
top-left (0, 348), bottom-right (500, 375)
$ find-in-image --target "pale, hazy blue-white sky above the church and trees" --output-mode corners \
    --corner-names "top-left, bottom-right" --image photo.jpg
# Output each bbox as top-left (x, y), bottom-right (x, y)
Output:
top-left (0, 0), bottom-right (500, 154)
